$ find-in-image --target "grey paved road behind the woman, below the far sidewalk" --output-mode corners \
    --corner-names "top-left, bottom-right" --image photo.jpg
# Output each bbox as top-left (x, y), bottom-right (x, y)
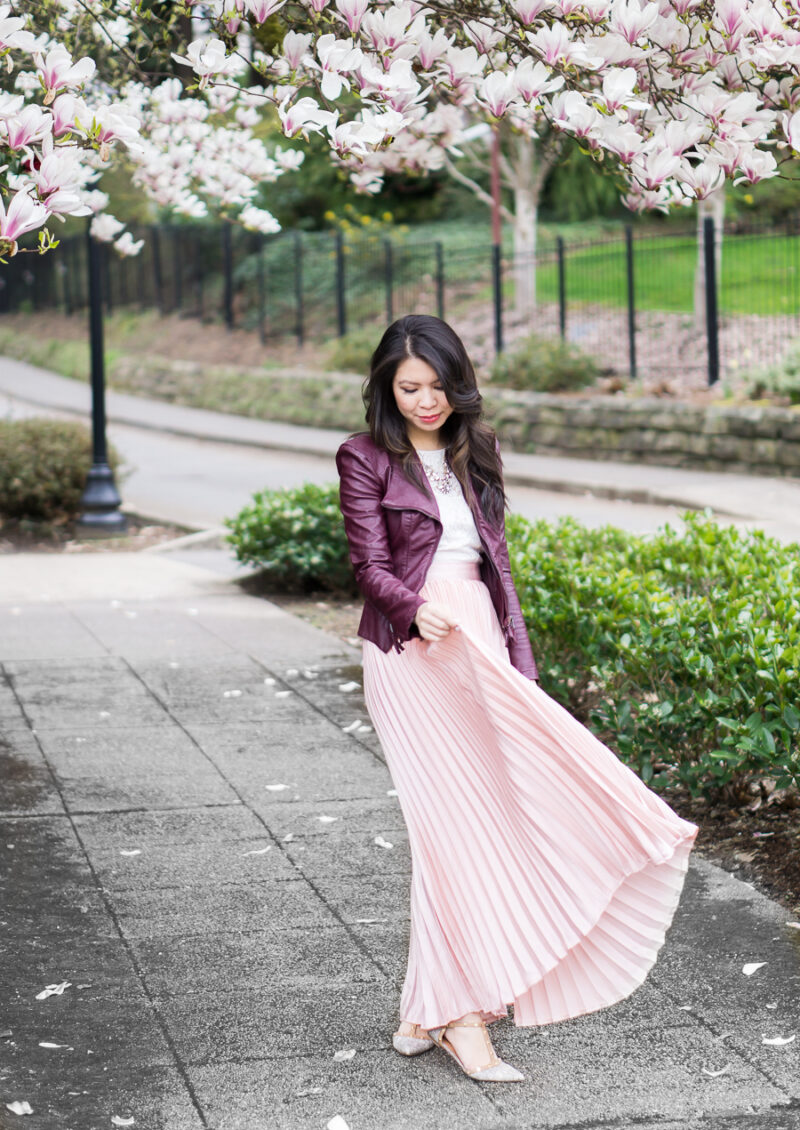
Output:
top-left (0, 394), bottom-right (758, 533)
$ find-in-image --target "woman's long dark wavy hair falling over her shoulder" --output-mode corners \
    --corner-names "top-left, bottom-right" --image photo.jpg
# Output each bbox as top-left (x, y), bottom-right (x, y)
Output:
top-left (362, 314), bottom-right (506, 525)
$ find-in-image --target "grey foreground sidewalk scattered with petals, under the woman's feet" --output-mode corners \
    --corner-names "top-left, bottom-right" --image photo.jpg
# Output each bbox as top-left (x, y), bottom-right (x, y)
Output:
top-left (0, 553), bottom-right (800, 1130)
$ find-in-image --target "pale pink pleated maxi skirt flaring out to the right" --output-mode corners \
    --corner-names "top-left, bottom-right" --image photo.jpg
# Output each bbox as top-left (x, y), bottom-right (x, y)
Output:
top-left (364, 565), bottom-right (698, 1028)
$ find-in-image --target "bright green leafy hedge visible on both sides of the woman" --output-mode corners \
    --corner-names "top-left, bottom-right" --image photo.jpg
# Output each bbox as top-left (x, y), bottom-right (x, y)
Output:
top-left (227, 486), bottom-right (800, 802)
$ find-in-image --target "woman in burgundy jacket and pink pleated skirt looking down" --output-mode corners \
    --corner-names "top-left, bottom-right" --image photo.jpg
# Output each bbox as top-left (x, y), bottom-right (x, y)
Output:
top-left (337, 315), bottom-right (697, 1081)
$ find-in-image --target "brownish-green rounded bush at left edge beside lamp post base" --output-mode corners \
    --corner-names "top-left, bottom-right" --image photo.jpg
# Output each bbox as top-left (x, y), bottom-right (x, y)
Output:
top-left (0, 417), bottom-right (120, 524)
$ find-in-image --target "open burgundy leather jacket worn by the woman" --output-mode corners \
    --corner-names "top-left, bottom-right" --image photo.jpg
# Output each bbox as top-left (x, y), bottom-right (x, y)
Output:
top-left (336, 433), bottom-right (539, 679)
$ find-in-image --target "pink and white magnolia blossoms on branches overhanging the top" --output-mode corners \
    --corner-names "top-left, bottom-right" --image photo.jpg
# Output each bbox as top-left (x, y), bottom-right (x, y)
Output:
top-left (0, 0), bottom-right (800, 266)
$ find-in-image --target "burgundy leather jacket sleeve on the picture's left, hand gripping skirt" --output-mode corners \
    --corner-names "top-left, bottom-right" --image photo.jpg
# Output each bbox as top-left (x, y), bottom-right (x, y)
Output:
top-left (336, 443), bottom-right (425, 650)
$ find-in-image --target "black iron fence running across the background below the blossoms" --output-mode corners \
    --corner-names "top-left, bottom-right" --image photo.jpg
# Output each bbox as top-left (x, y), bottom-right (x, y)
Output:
top-left (0, 221), bottom-right (800, 383)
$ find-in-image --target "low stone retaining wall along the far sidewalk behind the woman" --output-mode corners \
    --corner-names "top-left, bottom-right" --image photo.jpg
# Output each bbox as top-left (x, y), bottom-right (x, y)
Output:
top-left (114, 360), bottom-right (800, 478)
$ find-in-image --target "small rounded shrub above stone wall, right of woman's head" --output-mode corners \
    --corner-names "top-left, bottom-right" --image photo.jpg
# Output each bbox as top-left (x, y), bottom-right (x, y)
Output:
top-left (489, 334), bottom-right (600, 392)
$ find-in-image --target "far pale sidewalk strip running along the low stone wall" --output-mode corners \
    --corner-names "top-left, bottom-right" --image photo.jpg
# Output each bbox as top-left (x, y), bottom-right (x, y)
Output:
top-left (0, 358), bottom-right (800, 541)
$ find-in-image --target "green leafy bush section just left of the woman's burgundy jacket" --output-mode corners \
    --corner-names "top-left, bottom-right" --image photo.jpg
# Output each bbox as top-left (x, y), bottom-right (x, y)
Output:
top-left (225, 484), bottom-right (356, 593)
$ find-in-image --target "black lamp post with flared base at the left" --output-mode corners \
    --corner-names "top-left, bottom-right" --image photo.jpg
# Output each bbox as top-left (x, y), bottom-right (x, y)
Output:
top-left (77, 228), bottom-right (128, 538)
